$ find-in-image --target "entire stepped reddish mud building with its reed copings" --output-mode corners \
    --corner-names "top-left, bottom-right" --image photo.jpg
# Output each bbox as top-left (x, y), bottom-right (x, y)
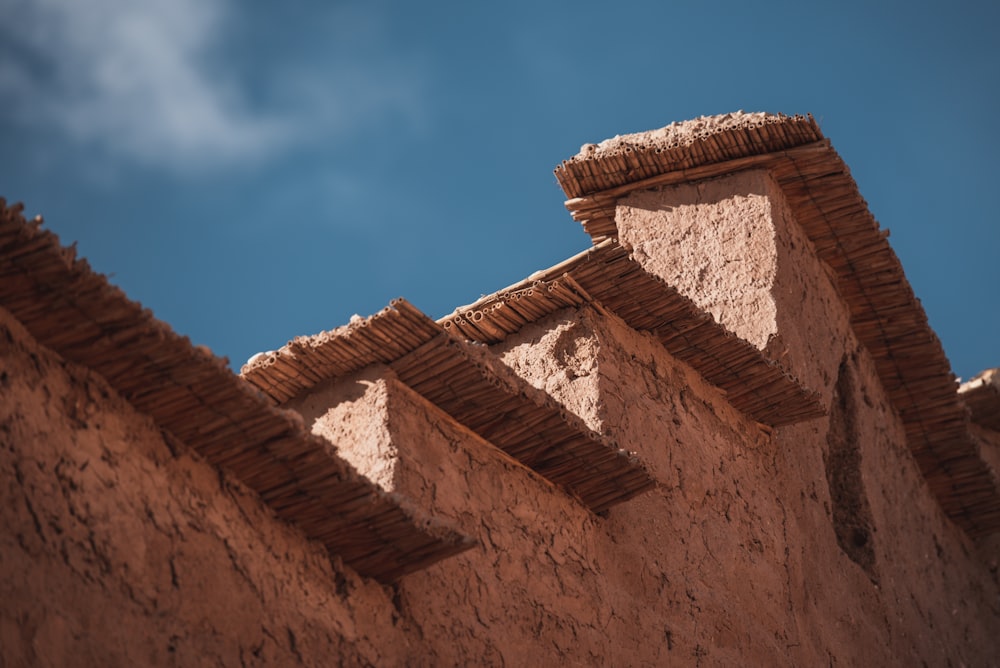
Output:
top-left (0, 113), bottom-right (1000, 666)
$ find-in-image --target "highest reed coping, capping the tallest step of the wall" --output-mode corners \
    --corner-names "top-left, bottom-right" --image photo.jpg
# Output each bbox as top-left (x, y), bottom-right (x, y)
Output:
top-left (556, 114), bottom-right (1000, 537)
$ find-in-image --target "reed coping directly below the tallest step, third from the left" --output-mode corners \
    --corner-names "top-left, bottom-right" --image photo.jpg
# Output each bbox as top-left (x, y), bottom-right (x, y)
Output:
top-left (441, 238), bottom-right (824, 426)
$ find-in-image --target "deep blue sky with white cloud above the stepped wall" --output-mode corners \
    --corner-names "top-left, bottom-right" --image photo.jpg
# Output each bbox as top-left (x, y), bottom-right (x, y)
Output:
top-left (0, 0), bottom-right (1000, 378)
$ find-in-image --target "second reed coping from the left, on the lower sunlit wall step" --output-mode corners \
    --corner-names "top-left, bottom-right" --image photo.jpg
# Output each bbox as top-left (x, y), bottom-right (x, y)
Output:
top-left (243, 294), bottom-right (654, 512)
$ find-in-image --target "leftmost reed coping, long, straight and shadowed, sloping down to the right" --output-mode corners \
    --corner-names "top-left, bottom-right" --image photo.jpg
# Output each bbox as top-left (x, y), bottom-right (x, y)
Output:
top-left (0, 200), bottom-right (472, 580)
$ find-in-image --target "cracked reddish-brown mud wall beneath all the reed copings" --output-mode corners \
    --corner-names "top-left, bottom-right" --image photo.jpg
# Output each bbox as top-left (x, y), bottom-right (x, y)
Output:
top-left (0, 168), bottom-right (1000, 666)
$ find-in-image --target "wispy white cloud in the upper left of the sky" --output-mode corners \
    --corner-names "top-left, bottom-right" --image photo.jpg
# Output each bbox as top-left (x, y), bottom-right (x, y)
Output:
top-left (0, 0), bottom-right (424, 169)
